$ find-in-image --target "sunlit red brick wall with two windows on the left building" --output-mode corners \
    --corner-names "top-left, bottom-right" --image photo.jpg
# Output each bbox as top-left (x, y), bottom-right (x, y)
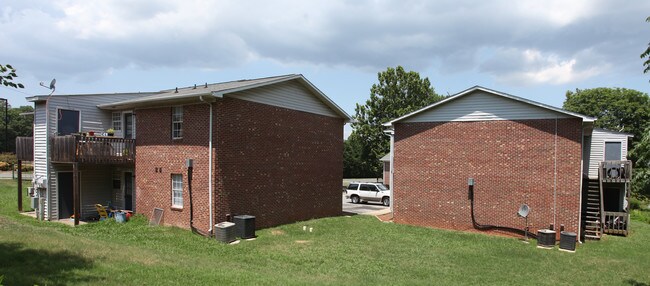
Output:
top-left (135, 104), bottom-right (209, 231)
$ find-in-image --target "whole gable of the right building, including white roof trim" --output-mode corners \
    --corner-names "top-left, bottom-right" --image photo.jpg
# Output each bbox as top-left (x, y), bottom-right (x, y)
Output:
top-left (384, 86), bottom-right (595, 126)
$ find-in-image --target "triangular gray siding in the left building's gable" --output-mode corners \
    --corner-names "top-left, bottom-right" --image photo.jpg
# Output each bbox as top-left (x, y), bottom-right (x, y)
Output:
top-left (227, 81), bottom-right (340, 117)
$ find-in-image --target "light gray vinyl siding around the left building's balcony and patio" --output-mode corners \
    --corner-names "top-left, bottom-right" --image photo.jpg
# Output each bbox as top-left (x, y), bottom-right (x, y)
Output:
top-left (34, 93), bottom-right (142, 220)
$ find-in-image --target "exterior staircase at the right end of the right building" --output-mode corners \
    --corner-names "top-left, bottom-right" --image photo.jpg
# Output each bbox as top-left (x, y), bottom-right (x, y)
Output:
top-left (582, 179), bottom-right (603, 240)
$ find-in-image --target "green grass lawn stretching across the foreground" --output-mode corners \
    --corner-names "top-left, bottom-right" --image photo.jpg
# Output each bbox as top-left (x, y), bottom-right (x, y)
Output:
top-left (0, 180), bottom-right (650, 285)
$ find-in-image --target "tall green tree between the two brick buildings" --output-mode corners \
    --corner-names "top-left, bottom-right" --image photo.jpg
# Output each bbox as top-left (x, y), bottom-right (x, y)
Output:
top-left (344, 66), bottom-right (443, 177)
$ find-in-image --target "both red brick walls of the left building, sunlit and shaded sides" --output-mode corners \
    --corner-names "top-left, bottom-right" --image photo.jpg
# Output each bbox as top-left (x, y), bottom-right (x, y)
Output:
top-left (136, 97), bottom-right (343, 231)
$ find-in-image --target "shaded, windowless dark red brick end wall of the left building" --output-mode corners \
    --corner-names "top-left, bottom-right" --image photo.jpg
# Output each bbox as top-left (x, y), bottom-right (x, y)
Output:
top-left (215, 98), bottom-right (343, 228)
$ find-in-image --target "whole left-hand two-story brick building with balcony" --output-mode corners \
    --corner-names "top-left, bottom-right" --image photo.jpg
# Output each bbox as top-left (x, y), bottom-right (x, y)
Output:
top-left (21, 75), bottom-right (350, 233)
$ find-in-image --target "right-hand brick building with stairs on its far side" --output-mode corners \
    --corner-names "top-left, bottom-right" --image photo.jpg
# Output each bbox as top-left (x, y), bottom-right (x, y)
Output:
top-left (385, 86), bottom-right (627, 239)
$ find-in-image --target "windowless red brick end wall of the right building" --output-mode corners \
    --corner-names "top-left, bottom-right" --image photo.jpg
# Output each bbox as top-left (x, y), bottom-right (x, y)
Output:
top-left (393, 119), bottom-right (582, 236)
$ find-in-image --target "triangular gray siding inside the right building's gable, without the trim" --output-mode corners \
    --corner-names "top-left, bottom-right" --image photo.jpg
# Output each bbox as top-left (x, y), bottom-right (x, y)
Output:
top-left (403, 91), bottom-right (570, 122)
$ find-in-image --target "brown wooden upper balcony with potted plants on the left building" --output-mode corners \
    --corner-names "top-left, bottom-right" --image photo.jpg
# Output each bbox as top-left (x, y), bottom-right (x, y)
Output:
top-left (50, 135), bottom-right (135, 165)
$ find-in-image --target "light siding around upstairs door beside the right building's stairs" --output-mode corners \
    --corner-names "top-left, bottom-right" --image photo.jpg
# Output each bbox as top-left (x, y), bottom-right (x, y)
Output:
top-left (588, 129), bottom-right (628, 179)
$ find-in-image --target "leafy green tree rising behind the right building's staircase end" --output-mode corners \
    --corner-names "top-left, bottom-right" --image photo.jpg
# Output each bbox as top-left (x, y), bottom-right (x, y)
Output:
top-left (563, 87), bottom-right (650, 141)
